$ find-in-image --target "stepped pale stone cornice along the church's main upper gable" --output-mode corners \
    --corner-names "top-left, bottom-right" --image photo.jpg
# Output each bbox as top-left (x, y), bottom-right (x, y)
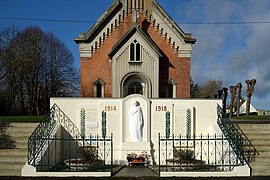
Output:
top-left (74, 0), bottom-right (196, 57)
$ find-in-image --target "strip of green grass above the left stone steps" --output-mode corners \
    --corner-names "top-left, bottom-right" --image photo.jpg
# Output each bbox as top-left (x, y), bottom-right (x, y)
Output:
top-left (0, 116), bottom-right (45, 123)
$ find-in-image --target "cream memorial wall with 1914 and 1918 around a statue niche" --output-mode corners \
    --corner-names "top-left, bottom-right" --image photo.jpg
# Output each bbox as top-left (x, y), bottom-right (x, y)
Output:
top-left (51, 95), bottom-right (221, 161)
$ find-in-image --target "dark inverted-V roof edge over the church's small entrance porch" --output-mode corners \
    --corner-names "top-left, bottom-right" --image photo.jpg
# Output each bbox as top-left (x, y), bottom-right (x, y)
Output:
top-left (109, 24), bottom-right (162, 58)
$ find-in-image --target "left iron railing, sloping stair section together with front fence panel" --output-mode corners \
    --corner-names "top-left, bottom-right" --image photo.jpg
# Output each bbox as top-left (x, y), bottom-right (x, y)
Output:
top-left (28, 104), bottom-right (113, 172)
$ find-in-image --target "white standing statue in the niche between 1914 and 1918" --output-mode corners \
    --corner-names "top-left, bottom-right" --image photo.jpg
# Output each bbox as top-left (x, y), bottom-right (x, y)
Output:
top-left (128, 100), bottom-right (143, 142)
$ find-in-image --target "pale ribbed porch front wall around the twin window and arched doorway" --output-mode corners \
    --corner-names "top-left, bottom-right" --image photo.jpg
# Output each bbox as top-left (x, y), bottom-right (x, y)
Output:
top-left (112, 32), bottom-right (159, 98)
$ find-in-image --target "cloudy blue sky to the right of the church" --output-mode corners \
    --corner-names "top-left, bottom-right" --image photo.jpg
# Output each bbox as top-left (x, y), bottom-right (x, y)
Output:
top-left (159, 0), bottom-right (270, 109)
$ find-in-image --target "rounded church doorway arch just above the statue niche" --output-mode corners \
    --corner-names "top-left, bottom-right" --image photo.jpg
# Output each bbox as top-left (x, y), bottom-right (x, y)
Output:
top-left (121, 73), bottom-right (151, 98)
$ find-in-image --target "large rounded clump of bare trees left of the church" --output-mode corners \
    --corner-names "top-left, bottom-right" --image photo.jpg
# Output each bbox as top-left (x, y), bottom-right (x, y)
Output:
top-left (1, 27), bottom-right (79, 115)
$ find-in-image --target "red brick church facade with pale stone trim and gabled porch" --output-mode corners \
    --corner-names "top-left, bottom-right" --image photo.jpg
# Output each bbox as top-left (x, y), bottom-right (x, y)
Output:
top-left (75, 0), bottom-right (196, 98)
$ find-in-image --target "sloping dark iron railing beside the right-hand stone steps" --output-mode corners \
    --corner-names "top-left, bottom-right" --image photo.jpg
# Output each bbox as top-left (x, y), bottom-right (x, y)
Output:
top-left (217, 105), bottom-right (259, 164)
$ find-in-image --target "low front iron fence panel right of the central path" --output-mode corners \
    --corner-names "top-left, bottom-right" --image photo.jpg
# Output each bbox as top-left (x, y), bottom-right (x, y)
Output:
top-left (158, 135), bottom-right (244, 174)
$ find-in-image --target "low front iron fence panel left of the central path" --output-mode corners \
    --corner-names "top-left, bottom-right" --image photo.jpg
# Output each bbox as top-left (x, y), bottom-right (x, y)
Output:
top-left (36, 134), bottom-right (113, 173)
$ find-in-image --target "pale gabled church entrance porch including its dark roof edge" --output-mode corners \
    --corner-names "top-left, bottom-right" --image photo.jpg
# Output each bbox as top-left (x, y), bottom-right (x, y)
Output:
top-left (109, 25), bottom-right (162, 97)
